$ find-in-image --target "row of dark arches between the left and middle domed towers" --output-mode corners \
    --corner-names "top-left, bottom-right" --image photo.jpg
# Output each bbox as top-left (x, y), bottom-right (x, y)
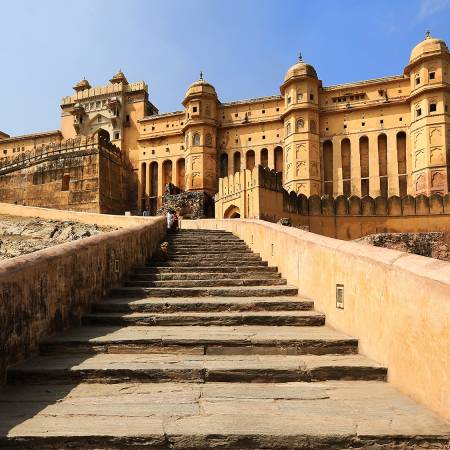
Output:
top-left (219, 147), bottom-right (283, 178)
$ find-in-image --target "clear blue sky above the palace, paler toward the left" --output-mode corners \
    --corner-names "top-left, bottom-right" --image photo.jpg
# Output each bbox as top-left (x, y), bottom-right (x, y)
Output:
top-left (0, 0), bottom-right (450, 135)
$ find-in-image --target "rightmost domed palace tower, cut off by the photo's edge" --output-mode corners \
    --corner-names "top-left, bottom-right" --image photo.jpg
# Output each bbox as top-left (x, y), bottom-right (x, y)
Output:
top-left (405, 32), bottom-right (450, 195)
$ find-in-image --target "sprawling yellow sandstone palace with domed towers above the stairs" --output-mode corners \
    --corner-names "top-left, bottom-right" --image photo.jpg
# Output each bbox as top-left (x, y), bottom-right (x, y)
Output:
top-left (0, 33), bottom-right (450, 213)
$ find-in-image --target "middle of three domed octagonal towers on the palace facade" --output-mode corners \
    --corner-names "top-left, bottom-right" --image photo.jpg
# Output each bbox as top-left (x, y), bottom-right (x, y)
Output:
top-left (280, 55), bottom-right (321, 196)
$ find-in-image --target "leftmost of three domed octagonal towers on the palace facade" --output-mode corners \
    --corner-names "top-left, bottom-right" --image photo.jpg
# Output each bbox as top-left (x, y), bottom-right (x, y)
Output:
top-left (183, 73), bottom-right (218, 196)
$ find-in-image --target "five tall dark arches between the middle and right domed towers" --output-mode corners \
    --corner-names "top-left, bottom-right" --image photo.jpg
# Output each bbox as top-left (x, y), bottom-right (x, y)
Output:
top-left (323, 131), bottom-right (408, 197)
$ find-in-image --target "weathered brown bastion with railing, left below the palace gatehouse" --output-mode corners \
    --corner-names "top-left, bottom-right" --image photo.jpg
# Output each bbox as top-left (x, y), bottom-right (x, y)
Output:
top-left (0, 132), bottom-right (132, 214)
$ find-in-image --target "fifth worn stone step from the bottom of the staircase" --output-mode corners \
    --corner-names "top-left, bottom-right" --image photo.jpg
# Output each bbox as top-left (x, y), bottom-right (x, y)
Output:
top-left (92, 296), bottom-right (314, 313)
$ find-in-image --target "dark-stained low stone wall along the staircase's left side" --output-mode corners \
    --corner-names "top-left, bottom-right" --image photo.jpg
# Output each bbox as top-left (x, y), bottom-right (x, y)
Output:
top-left (0, 211), bottom-right (166, 384)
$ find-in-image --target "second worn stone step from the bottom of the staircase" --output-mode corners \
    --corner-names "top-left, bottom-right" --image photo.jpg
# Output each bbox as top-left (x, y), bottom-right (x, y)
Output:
top-left (8, 353), bottom-right (387, 384)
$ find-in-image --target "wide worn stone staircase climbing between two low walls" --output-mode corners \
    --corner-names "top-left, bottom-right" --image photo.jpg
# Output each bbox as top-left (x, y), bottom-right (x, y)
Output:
top-left (0, 230), bottom-right (450, 449)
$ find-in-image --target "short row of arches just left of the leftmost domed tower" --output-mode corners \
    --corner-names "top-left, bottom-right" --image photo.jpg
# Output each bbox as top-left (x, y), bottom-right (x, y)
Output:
top-left (141, 158), bottom-right (186, 198)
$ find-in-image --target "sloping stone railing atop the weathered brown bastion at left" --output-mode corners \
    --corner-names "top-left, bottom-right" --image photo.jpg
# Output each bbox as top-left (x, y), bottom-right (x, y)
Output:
top-left (0, 132), bottom-right (122, 175)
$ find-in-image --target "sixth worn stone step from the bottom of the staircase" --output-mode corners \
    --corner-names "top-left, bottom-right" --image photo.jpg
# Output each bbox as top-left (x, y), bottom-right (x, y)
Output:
top-left (110, 285), bottom-right (298, 298)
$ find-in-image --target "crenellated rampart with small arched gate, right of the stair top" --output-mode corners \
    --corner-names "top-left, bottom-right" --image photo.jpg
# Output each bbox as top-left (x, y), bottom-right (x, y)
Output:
top-left (215, 166), bottom-right (450, 240)
